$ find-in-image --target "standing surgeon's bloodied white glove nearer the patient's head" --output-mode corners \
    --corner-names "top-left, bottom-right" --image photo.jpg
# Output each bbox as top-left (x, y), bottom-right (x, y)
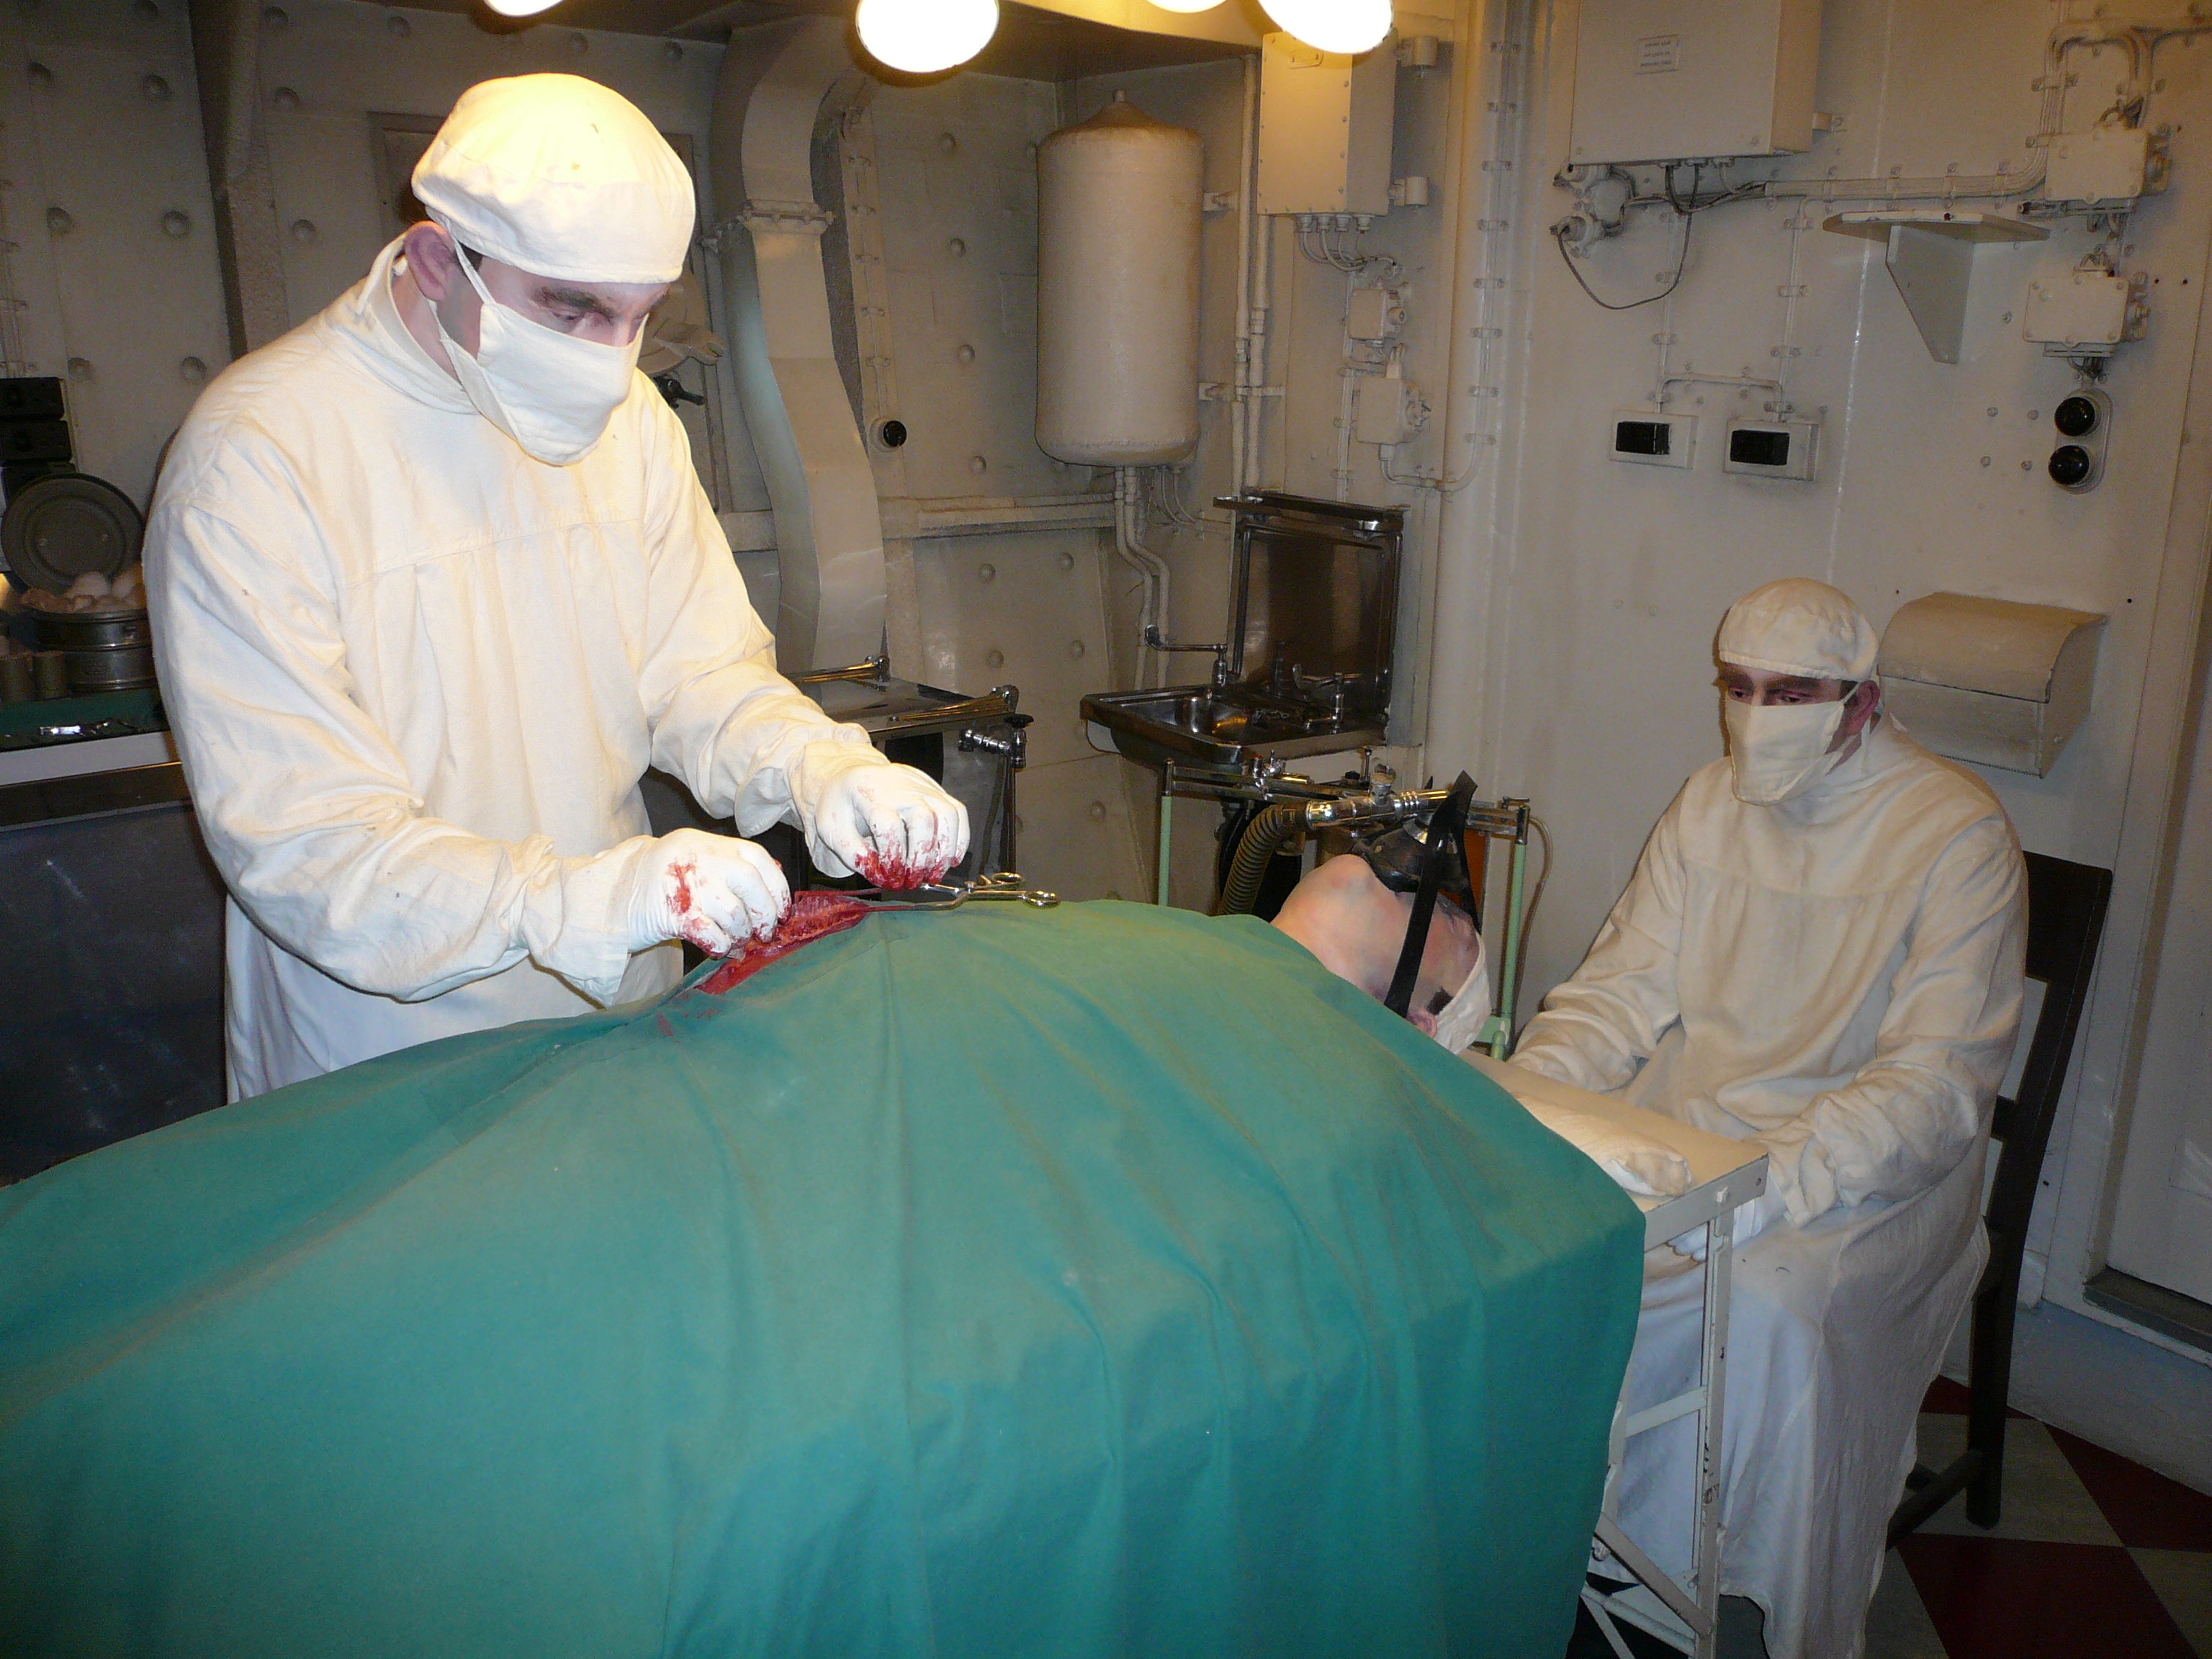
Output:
top-left (792, 743), bottom-right (966, 887)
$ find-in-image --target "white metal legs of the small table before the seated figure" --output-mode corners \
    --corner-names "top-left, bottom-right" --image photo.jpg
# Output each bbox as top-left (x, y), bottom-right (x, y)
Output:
top-left (1581, 1153), bottom-right (1768, 1659)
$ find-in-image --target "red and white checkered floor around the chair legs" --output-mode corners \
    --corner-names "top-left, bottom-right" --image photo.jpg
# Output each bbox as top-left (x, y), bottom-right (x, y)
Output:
top-left (1568, 1380), bottom-right (2212, 1659)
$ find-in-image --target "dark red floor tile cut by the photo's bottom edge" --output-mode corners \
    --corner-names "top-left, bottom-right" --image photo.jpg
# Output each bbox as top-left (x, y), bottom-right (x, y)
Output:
top-left (1898, 1533), bottom-right (2196, 1659)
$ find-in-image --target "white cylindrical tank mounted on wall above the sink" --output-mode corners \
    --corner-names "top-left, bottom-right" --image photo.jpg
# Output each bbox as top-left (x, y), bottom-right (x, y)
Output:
top-left (1038, 93), bottom-right (1205, 467)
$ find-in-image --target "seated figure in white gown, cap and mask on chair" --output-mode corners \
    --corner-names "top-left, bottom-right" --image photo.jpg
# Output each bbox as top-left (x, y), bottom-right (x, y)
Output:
top-left (1513, 580), bottom-right (2026, 1659)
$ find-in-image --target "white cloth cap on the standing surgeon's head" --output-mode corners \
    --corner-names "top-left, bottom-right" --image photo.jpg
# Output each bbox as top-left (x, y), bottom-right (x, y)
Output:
top-left (413, 75), bottom-right (693, 283)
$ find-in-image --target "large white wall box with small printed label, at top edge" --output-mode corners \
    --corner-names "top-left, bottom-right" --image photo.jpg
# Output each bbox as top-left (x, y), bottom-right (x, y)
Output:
top-left (1568, 0), bottom-right (1820, 166)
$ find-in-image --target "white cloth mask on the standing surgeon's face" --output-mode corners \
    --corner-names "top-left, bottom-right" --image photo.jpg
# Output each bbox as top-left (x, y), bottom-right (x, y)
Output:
top-left (429, 231), bottom-right (646, 467)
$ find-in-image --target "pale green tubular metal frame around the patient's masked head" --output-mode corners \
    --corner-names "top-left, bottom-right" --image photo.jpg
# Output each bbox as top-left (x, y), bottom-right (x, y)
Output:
top-left (1153, 750), bottom-right (1530, 1057)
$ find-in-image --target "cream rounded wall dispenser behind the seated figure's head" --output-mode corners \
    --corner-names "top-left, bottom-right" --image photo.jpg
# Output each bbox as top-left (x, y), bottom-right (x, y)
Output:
top-left (1880, 593), bottom-right (2106, 776)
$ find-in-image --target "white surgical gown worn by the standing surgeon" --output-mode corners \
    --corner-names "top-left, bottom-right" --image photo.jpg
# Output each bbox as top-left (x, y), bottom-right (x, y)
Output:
top-left (146, 243), bottom-right (867, 1097)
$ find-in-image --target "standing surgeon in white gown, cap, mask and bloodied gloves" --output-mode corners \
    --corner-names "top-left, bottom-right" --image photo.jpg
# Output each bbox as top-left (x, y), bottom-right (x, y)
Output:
top-left (146, 75), bottom-right (966, 1097)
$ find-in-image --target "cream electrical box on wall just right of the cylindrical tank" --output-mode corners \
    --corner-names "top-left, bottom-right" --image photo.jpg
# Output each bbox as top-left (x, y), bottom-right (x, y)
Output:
top-left (1259, 33), bottom-right (1398, 215)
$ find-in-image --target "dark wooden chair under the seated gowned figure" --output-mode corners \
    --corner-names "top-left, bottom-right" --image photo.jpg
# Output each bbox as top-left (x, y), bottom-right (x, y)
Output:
top-left (1889, 852), bottom-right (2113, 1544)
